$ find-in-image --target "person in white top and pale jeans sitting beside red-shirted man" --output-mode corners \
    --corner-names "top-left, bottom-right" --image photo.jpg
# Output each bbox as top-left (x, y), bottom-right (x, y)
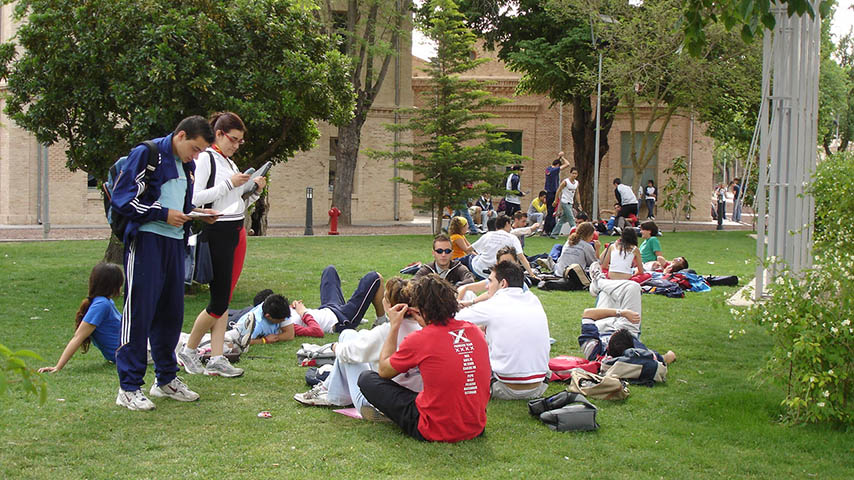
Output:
top-left (294, 277), bottom-right (423, 412)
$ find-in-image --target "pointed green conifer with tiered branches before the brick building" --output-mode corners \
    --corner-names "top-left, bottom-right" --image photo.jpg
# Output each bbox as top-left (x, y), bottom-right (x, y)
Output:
top-left (374, 0), bottom-right (523, 231)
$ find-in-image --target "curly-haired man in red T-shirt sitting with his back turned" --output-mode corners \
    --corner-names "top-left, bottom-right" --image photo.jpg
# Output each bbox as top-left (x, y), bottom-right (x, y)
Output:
top-left (359, 274), bottom-right (492, 442)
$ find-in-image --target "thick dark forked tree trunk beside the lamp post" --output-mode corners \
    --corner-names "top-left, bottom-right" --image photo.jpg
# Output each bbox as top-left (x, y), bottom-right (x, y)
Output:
top-left (571, 96), bottom-right (617, 220)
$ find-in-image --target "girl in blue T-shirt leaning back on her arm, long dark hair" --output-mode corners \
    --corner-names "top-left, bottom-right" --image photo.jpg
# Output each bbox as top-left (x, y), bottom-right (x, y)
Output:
top-left (39, 262), bottom-right (125, 373)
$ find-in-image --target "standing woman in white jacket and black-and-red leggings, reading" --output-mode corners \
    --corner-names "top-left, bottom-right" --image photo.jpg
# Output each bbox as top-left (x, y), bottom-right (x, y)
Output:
top-left (178, 112), bottom-right (266, 377)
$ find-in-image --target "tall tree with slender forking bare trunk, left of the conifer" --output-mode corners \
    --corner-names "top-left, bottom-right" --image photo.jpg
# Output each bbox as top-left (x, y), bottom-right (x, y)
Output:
top-left (318, 0), bottom-right (411, 225)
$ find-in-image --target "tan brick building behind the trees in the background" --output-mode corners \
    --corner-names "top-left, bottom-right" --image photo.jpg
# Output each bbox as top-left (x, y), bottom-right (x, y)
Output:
top-left (0, 19), bottom-right (712, 225)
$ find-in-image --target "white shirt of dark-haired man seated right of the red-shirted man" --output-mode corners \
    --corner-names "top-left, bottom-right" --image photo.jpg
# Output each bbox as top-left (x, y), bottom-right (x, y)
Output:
top-left (454, 287), bottom-right (550, 384)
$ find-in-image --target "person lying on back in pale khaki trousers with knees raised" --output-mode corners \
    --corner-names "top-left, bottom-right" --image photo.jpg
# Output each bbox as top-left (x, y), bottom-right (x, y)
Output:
top-left (578, 262), bottom-right (676, 364)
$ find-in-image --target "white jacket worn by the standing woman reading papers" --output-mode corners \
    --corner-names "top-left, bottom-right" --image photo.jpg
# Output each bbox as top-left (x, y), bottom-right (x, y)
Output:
top-left (193, 148), bottom-right (261, 222)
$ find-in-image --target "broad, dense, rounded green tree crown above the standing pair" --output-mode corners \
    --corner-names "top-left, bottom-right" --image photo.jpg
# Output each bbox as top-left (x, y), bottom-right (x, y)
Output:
top-left (0, 0), bottom-right (353, 227)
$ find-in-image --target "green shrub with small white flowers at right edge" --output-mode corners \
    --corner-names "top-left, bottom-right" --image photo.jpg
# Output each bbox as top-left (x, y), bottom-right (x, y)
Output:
top-left (731, 154), bottom-right (854, 425)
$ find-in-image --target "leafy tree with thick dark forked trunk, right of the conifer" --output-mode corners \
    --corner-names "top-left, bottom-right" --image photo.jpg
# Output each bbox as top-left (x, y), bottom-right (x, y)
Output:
top-left (461, 0), bottom-right (618, 214)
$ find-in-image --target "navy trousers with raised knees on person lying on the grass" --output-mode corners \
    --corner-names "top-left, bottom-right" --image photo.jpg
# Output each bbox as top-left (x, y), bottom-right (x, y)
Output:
top-left (318, 265), bottom-right (382, 332)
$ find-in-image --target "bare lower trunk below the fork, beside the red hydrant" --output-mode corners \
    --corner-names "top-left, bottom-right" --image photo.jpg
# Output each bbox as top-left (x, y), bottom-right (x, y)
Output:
top-left (332, 113), bottom-right (367, 225)
